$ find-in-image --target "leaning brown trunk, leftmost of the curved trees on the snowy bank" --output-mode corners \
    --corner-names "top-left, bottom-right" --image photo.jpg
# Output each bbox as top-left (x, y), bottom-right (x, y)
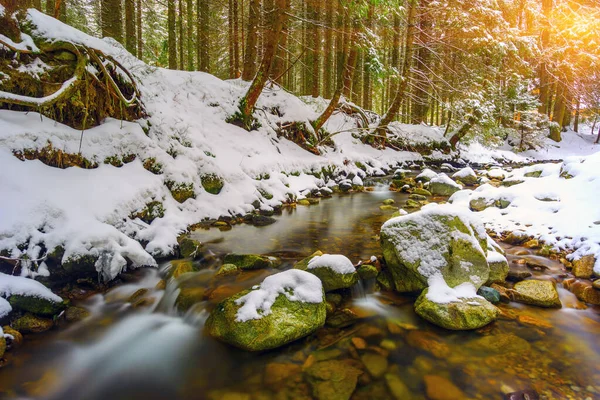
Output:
top-left (240, 0), bottom-right (287, 130)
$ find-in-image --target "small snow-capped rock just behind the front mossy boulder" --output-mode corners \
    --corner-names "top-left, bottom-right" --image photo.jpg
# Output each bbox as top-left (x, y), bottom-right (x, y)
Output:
top-left (294, 251), bottom-right (358, 292)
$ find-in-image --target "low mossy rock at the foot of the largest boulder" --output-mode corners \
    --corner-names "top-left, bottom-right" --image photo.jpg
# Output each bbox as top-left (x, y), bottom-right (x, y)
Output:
top-left (415, 288), bottom-right (498, 330)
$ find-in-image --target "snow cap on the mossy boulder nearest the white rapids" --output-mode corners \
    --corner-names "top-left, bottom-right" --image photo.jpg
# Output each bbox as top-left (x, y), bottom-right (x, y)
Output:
top-left (235, 269), bottom-right (323, 322)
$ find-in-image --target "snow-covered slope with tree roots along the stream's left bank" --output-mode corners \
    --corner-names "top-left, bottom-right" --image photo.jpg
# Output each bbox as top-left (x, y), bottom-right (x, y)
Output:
top-left (0, 10), bottom-right (600, 279)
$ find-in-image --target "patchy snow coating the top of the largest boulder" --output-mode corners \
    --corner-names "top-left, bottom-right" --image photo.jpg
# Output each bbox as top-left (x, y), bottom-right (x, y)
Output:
top-left (381, 203), bottom-right (487, 278)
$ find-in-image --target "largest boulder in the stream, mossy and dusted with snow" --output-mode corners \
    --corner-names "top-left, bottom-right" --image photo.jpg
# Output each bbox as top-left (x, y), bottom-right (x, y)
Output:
top-left (380, 204), bottom-right (490, 292)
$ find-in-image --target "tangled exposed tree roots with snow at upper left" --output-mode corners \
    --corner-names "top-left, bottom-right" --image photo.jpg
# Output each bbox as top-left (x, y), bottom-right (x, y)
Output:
top-left (0, 16), bottom-right (144, 130)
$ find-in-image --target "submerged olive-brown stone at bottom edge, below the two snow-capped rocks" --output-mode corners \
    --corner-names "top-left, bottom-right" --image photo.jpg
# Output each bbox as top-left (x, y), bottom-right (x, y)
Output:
top-left (306, 360), bottom-right (362, 400)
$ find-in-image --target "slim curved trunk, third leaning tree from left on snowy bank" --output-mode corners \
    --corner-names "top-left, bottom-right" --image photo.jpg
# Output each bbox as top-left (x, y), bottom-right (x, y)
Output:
top-left (376, 0), bottom-right (419, 144)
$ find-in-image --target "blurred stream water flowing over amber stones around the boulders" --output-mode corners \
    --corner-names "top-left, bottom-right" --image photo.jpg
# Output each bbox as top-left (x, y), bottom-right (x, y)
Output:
top-left (0, 186), bottom-right (600, 400)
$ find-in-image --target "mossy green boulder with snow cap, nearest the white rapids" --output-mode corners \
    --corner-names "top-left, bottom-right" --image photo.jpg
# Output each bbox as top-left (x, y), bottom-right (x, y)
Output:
top-left (205, 269), bottom-right (326, 351)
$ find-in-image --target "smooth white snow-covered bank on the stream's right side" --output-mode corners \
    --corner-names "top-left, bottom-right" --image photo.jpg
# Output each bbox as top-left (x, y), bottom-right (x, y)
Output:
top-left (450, 152), bottom-right (600, 275)
